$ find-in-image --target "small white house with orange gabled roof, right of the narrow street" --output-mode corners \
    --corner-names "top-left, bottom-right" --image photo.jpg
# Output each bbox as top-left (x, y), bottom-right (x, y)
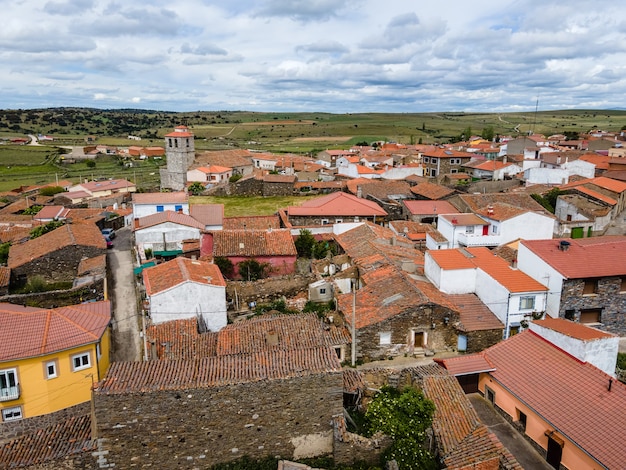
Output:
top-left (142, 257), bottom-right (227, 331)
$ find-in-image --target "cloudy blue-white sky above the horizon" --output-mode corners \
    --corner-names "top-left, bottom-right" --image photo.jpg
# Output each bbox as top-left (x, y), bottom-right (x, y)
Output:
top-left (0, 0), bottom-right (626, 113)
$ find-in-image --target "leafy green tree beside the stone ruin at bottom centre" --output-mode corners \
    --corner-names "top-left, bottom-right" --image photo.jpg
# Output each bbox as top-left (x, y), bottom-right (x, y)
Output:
top-left (365, 386), bottom-right (438, 470)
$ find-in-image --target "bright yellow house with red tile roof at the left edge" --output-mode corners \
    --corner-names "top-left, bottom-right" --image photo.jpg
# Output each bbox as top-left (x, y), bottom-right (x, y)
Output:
top-left (0, 301), bottom-right (111, 422)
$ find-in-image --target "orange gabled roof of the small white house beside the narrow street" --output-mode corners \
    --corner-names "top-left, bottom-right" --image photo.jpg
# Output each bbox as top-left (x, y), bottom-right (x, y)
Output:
top-left (142, 256), bottom-right (226, 295)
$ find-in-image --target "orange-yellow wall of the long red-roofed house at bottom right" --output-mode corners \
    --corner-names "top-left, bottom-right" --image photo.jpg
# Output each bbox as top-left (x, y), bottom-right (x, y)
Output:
top-left (478, 374), bottom-right (604, 470)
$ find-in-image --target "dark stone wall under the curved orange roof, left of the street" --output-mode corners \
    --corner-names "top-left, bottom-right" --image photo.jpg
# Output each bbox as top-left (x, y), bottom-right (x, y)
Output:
top-left (11, 245), bottom-right (106, 284)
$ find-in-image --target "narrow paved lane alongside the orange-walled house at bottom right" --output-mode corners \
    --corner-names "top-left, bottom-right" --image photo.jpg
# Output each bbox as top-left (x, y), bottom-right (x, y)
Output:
top-left (467, 393), bottom-right (554, 470)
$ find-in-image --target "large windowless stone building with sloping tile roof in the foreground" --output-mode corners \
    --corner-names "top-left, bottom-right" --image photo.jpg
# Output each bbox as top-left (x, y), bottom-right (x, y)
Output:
top-left (94, 347), bottom-right (343, 468)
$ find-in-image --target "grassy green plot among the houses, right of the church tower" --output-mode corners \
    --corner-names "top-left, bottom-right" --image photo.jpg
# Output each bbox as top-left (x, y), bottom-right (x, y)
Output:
top-left (189, 196), bottom-right (319, 217)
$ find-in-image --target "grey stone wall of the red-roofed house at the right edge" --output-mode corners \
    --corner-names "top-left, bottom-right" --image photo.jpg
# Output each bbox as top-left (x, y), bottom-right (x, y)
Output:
top-left (559, 277), bottom-right (626, 336)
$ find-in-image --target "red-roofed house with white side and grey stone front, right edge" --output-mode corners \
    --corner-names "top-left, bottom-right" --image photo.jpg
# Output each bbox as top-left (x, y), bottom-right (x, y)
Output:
top-left (517, 236), bottom-right (626, 336)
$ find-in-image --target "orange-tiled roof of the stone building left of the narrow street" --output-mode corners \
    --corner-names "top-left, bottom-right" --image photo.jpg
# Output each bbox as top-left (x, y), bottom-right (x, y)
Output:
top-left (7, 223), bottom-right (106, 269)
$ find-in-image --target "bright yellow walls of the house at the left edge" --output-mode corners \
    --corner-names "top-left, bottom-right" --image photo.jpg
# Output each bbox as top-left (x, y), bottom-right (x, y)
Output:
top-left (0, 328), bottom-right (110, 418)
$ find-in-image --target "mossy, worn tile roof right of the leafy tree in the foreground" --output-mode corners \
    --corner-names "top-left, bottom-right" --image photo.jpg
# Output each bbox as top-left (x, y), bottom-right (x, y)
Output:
top-left (423, 374), bottom-right (522, 470)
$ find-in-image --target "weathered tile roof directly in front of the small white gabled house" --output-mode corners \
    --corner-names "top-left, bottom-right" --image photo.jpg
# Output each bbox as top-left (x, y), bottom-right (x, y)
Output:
top-left (146, 318), bottom-right (218, 360)
